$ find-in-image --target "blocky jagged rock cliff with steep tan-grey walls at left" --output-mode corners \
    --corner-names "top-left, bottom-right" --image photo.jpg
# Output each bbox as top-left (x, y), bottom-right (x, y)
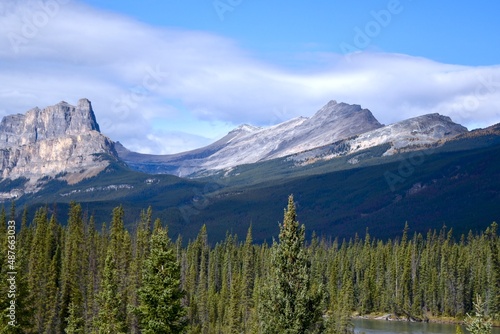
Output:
top-left (0, 99), bottom-right (116, 197)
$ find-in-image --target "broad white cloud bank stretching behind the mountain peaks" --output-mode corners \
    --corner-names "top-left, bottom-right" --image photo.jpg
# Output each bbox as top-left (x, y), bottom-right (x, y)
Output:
top-left (0, 0), bottom-right (500, 153)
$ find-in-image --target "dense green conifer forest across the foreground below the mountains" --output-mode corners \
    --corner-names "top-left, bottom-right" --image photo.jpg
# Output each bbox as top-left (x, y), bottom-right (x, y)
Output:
top-left (0, 197), bottom-right (500, 333)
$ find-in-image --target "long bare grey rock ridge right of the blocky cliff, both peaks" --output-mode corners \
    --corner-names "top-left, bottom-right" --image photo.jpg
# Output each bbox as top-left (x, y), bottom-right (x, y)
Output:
top-left (117, 100), bottom-right (467, 177)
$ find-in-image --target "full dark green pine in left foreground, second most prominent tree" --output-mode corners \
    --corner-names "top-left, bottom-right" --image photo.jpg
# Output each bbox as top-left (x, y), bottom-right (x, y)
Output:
top-left (138, 223), bottom-right (186, 334)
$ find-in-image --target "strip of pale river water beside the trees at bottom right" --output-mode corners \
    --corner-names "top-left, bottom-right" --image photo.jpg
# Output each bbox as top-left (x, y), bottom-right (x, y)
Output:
top-left (352, 319), bottom-right (500, 334)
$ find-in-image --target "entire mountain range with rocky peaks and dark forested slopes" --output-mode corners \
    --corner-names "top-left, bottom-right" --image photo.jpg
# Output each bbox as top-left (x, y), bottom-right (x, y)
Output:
top-left (0, 99), bottom-right (500, 241)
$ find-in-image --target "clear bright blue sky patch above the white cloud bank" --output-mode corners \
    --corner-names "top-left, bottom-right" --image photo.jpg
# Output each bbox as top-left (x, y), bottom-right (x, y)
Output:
top-left (75, 0), bottom-right (500, 66)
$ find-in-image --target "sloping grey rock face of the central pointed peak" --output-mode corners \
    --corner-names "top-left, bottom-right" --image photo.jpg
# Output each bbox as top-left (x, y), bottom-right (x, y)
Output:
top-left (119, 101), bottom-right (382, 176)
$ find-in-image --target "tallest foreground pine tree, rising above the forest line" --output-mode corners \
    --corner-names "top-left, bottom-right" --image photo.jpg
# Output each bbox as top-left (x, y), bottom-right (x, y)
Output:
top-left (260, 195), bottom-right (322, 334)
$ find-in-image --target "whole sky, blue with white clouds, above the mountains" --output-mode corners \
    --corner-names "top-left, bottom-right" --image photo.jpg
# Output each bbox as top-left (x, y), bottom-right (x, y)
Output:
top-left (0, 0), bottom-right (500, 153)
